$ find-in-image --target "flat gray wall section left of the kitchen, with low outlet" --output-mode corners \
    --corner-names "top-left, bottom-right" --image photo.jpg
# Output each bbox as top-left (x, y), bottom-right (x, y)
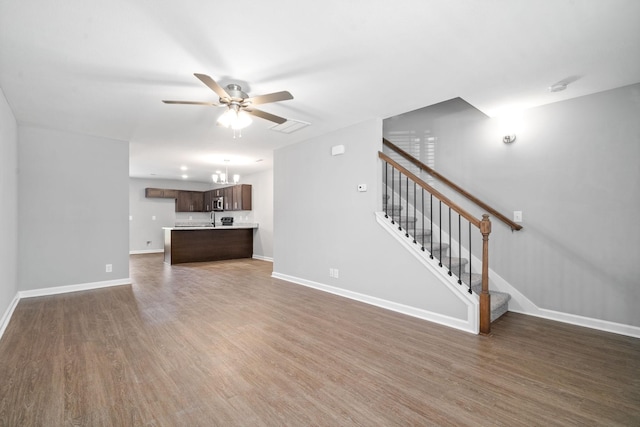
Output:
top-left (18, 126), bottom-right (129, 291)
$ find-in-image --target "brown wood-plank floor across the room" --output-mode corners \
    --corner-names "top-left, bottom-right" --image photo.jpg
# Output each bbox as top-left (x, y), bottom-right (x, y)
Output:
top-left (0, 254), bottom-right (640, 426)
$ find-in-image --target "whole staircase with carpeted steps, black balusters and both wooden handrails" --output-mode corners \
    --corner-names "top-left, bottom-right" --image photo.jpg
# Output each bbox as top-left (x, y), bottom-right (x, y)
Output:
top-left (378, 139), bottom-right (522, 334)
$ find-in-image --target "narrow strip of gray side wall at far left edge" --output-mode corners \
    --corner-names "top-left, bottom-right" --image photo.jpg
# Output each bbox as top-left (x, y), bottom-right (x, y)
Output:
top-left (0, 90), bottom-right (18, 326)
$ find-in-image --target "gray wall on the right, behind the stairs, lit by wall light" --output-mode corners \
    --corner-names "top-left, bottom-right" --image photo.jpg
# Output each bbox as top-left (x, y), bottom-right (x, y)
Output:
top-left (385, 84), bottom-right (640, 326)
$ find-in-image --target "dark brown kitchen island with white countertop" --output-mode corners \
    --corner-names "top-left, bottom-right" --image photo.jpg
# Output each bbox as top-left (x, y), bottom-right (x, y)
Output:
top-left (163, 224), bottom-right (258, 264)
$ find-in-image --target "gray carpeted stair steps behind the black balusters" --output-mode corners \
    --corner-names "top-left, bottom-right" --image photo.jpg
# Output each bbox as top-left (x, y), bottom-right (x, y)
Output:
top-left (383, 195), bottom-right (511, 322)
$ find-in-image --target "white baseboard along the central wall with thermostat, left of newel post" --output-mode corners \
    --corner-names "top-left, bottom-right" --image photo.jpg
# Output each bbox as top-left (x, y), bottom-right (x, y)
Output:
top-left (271, 272), bottom-right (478, 334)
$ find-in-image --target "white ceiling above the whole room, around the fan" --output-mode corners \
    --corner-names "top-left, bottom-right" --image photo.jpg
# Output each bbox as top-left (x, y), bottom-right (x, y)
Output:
top-left (0, 0), bottom-right (640, 182)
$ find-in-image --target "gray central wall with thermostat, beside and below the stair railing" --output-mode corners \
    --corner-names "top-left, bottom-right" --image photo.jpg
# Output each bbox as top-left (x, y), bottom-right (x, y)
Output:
top-left (274, 120), bottom-right (466, 319)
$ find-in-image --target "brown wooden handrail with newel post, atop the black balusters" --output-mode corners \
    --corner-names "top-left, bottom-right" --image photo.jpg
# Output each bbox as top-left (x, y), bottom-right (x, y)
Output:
top-left (378, 151), bottom-right (491, 334)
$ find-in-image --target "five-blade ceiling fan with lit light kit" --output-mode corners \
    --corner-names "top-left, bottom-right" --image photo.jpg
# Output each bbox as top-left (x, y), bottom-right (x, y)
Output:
top-left (162, 73), bottom-right (293, 130)
